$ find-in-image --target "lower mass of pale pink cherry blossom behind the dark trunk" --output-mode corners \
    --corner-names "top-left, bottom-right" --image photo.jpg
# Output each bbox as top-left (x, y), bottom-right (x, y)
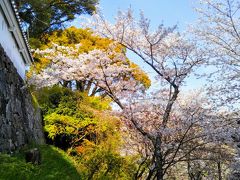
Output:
top-left (122, 93), bottom-right (236, 179)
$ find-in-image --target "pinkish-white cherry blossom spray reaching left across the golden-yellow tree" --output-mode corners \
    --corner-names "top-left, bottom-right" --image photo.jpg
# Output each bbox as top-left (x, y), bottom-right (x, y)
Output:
top-left (29, 43), bottom-right (150, 107)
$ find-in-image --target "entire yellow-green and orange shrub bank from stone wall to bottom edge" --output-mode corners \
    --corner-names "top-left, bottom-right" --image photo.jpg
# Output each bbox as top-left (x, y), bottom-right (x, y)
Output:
top-left (32, 86), bottom-right (137, 180)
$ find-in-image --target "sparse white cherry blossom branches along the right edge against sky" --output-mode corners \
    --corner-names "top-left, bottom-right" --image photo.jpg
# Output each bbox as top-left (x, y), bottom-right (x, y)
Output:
top-left (193, 0), bottom-right (240, 107)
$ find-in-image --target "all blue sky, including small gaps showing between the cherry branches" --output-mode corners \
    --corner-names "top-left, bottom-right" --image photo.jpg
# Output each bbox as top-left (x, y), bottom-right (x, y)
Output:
top-left (71, 0), bottom-right (204, 90)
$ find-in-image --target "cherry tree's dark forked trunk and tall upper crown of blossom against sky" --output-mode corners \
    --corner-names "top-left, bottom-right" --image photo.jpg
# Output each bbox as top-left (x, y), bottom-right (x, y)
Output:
top-left (84, 10), bottom-right (203, 179)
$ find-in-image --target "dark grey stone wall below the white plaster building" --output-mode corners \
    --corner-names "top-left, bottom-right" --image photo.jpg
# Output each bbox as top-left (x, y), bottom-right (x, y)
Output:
top-left (0, 45), bottom-right (44, 152)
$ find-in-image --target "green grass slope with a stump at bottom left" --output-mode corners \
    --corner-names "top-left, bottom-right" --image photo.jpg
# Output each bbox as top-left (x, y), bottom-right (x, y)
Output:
top-left (0, 145), bottom-right (82, 180)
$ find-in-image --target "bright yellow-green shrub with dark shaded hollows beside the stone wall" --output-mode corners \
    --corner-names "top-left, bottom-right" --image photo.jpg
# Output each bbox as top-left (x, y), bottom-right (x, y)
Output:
top-left (36, 86), bottom-right (119, 148)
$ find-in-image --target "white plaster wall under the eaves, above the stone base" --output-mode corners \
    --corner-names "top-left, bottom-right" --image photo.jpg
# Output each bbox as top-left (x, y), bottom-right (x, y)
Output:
top-left (0, 10), bottom-right (27, 79)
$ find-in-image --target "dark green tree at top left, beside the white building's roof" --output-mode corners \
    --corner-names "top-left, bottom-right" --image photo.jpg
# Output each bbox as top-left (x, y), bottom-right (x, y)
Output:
top-left (17, 0), bottom-right (98, 39)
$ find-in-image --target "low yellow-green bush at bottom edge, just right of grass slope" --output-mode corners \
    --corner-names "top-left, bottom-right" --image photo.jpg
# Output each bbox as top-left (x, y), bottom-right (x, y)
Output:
top-left (78, 142), bottom-right (137, 180)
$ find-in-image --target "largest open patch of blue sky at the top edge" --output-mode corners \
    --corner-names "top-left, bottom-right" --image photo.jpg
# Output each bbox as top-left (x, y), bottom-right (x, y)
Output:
top-left (99, 0), bottom-right (197, 31)
